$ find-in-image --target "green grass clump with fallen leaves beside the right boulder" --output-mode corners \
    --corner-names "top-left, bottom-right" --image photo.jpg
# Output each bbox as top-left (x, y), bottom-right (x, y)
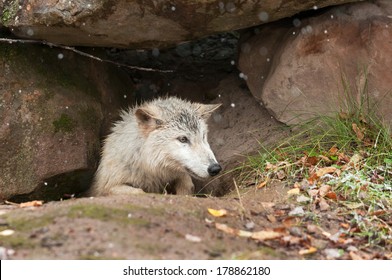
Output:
top-left (239, 70), bottom-right (392, 249)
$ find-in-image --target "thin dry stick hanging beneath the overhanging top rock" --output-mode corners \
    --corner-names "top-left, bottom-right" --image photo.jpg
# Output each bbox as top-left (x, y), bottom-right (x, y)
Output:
top-left (0, 38), bottom-right (173, 73)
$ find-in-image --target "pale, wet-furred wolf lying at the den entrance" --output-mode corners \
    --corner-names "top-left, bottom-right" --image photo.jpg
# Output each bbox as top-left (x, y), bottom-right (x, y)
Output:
top-left (89, 97), bottom-right (222, 196)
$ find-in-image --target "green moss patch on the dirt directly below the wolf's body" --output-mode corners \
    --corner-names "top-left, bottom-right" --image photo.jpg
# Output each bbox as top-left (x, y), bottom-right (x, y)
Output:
top-left (68, 204), bottom-right (150, 226)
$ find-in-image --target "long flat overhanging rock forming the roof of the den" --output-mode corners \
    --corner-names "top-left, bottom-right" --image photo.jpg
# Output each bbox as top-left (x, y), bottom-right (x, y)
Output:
top-left (0, 0), bottom-right (364, 48)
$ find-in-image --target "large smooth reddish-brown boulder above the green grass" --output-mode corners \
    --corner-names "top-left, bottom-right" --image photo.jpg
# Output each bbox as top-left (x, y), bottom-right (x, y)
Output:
top-left (239, 0), bottom-right (392, 124)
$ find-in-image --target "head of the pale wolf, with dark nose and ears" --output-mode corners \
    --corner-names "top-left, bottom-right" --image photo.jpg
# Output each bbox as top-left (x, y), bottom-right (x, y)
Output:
top-left (134, 97), bottom-right (221, 178)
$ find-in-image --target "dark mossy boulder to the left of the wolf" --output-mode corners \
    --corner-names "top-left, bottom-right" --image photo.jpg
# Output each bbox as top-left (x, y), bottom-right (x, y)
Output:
top-left (0, 44), bottom-right (133, 201)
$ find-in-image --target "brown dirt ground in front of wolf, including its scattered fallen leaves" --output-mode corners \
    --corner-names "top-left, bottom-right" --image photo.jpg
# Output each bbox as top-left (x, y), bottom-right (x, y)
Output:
top-left (0, 179), bottom-right (387, 259)
